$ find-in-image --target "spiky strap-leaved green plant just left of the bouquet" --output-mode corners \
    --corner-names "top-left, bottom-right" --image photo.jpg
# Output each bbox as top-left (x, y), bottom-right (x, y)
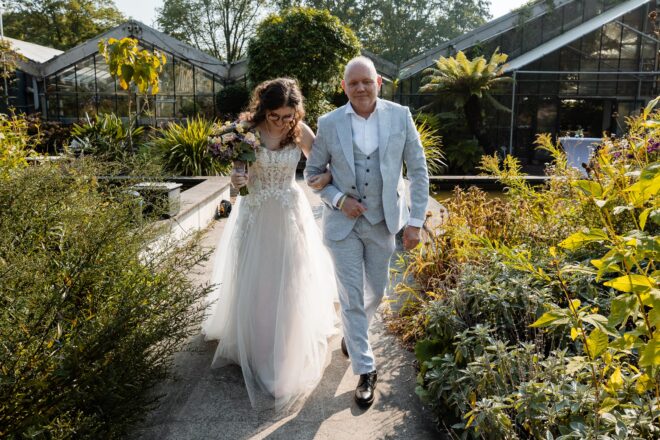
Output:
top-left (150, 117), bottom-right (230, 176)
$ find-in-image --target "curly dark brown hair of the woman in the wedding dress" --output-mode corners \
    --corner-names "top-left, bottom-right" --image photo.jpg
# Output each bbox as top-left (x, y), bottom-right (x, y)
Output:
top-left (239, 78), bottom-right (305, 147)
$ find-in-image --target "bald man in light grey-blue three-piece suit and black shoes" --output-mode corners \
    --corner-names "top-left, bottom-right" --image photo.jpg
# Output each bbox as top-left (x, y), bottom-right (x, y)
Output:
top-left (305, 57), bottom-right (429, 406)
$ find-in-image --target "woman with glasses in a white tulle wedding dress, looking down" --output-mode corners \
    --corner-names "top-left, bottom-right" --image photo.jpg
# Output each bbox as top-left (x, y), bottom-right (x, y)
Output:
top-left (202, 78), bottom-right (337, 410)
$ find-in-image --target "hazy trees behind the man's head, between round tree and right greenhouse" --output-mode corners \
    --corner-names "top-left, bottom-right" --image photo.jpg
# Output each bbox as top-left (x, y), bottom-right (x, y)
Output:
top-left (275, 0), bottom-right (490, 63)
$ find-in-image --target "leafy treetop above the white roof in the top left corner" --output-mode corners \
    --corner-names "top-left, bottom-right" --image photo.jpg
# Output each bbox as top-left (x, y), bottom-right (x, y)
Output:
top-left (3, 0), bottom-right (125, 50)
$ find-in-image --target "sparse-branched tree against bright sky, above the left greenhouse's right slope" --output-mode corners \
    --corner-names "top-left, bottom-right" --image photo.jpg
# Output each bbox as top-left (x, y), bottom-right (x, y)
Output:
top-left (156, 0), bottom-right (266, 63)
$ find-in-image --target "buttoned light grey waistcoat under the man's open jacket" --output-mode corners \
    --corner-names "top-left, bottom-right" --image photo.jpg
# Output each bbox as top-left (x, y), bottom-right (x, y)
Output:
top-left (353, 142), bottom-right (385, 225)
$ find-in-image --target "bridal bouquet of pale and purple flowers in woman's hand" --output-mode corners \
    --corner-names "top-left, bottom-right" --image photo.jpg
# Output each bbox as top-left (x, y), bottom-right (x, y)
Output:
top-left (208, 121), bottom-right (261, 196)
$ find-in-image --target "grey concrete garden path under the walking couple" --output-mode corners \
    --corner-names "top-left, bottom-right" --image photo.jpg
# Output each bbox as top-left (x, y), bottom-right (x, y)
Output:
top-left (133, 180), bottom-right (442, 440)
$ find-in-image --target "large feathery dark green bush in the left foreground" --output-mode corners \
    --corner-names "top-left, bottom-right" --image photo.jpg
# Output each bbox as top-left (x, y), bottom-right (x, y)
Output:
top-left (0, 160), bottom-right (208, 439)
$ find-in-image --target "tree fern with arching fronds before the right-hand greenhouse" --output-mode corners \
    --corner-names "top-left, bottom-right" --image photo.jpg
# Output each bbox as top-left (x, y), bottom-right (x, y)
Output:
top-left (419, 48), bottom-right (511, 154)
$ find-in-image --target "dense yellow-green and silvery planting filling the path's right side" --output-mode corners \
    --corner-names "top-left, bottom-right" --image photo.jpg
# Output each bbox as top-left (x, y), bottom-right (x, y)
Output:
top-left (395, 100), bottom-right (660, 439)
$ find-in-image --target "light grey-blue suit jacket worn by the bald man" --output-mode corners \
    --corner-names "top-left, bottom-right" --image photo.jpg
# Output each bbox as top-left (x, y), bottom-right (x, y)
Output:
top-left (305, 99), bottom-right (429, 241)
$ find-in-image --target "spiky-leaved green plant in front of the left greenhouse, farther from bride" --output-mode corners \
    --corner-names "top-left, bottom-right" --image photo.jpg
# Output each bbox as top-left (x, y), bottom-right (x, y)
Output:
top-left (71, 113), bottom-right (144, 161)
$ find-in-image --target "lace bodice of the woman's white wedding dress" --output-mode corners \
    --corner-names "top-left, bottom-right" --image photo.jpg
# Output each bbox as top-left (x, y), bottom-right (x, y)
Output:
top-left (244, 144), bottom-right (300, 211)
